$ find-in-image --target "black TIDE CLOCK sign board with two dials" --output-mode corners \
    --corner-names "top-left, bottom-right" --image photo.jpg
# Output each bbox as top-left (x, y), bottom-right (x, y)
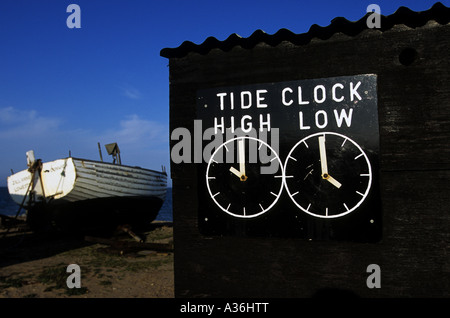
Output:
top-left (196, 74), bottom-right (382, 242)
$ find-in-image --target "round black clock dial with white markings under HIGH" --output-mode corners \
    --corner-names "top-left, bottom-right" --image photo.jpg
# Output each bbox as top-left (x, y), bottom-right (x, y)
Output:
top-left (206, 136), bottom-right (283, 218)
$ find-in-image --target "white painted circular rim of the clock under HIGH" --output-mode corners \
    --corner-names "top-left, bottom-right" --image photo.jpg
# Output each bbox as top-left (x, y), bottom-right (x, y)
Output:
top-left (205, 136), bottom-right (284, 219)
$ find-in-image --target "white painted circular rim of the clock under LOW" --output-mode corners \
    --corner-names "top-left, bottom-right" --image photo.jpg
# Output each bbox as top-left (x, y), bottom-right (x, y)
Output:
top-left (283, 131), bottom-right (372, 219)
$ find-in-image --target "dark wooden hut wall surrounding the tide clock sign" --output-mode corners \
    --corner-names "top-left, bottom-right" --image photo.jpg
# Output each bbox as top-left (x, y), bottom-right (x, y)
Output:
top-left (166, 21), bottom-right (450, 297)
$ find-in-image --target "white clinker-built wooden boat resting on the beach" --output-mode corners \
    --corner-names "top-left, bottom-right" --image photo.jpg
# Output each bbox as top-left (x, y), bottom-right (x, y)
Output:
top-left (8, 144), bottom-right (167, 229)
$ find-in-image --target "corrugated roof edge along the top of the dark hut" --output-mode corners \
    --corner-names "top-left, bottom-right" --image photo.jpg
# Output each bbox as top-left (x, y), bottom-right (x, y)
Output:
top-left (160, 2), bottom-right (450, 58)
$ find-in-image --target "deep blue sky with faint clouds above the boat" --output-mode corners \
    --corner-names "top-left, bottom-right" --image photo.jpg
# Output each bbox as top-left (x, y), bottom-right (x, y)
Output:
top-left (0, 0), bottom-right (444, 186)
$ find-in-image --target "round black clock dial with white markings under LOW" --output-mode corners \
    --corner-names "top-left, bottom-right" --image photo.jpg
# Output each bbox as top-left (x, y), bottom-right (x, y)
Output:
top-left (284, 132), bottom-right (372, 218)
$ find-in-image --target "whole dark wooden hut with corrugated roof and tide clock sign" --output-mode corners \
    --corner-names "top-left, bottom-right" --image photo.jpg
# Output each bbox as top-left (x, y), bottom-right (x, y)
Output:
top-left (161, 3), bottom-right (450, 297)
